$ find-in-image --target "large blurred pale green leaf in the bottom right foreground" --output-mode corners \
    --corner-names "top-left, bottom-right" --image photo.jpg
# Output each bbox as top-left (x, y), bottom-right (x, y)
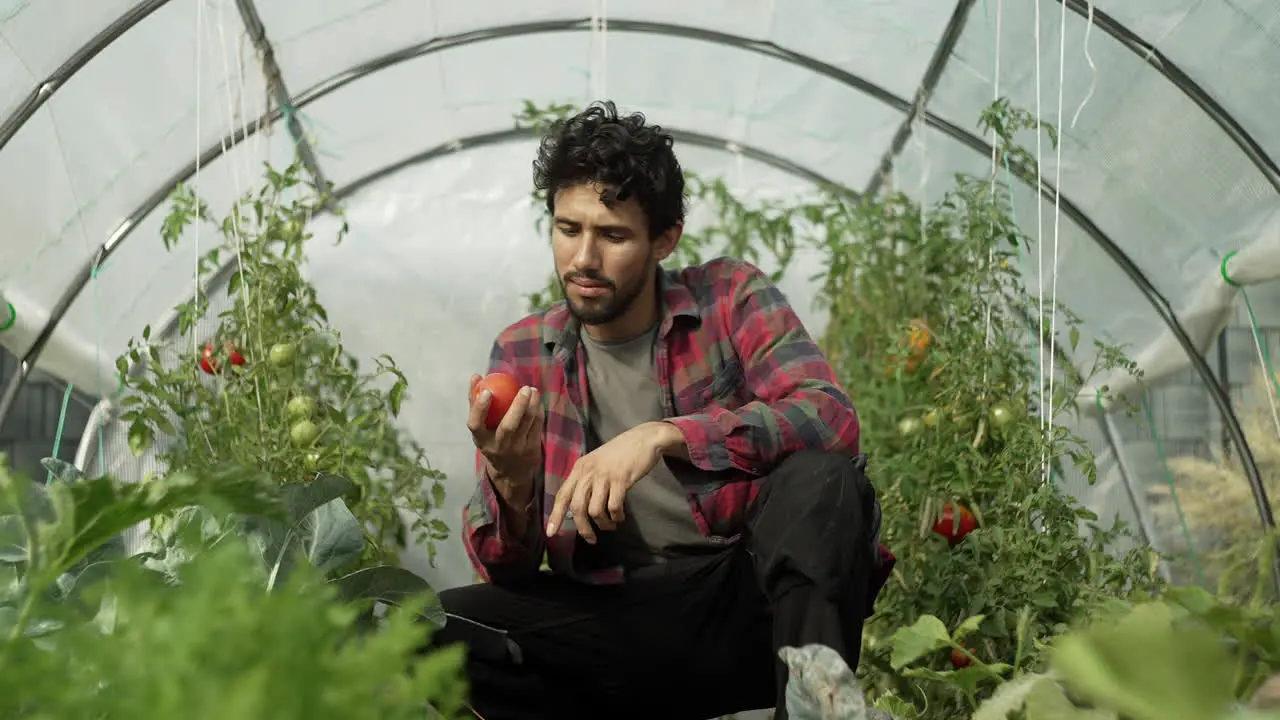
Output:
top-left (1052, 603), bottom-right (1234, 720)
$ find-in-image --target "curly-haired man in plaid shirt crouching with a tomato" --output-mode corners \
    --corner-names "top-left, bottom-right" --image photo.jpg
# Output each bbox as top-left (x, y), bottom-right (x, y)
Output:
top-left (436, 102), bottom-right (890, 720)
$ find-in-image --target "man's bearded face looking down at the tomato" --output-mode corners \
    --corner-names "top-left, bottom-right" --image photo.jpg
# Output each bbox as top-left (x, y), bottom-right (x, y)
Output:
top-left (552, 184), bottom-right (680, 332)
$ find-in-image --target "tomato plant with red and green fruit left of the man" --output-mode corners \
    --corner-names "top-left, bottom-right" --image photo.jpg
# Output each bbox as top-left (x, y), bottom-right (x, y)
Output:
top-left (116, 163), bottom-right (448, 564)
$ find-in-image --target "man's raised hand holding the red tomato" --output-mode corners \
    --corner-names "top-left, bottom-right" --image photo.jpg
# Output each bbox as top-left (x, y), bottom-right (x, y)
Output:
top-left (467, 375), bottom-right (543, 509)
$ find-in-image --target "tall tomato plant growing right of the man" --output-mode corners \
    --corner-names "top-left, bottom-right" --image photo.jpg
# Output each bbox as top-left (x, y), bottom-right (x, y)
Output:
top-left (803, 101), bottom-right (1157, 717)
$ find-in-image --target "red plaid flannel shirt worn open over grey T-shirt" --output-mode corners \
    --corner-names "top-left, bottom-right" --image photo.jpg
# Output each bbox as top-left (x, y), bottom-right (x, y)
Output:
top-left (463, 259), bottom-right (893, 592)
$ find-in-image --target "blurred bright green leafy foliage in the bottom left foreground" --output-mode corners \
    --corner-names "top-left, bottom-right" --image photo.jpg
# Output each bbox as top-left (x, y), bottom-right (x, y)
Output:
top-left (0, 456), bottom-right (466, 720)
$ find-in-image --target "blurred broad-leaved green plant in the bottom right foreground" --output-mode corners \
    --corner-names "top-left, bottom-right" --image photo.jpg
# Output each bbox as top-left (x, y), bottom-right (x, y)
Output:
top-left (891, 530), bottom-right (1280, 720)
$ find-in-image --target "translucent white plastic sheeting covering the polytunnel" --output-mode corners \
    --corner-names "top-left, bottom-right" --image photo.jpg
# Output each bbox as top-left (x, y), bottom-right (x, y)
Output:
top-left (0, 0), bottom-right (1280, 589)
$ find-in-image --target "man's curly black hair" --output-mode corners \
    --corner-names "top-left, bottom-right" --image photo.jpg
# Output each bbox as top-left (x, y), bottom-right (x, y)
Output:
top-left (534, 101), bottom-right (685, 237)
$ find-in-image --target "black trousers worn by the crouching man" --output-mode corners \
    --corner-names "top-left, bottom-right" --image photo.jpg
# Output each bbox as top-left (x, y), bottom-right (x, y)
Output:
top-left (433, 452), bottom-right (879, 720)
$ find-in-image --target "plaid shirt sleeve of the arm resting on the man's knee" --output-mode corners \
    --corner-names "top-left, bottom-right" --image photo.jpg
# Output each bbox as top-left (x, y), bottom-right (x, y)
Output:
top-left (667, 264), bottom-right (859, 475)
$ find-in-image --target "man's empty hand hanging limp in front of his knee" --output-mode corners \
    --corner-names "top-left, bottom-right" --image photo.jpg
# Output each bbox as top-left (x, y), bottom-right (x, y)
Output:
top-left (547, 423), bottom-right (680, 544)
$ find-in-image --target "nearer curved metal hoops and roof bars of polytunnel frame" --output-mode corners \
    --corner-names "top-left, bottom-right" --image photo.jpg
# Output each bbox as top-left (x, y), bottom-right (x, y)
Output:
top-left (0, 0), bottom-right (1280, 535)
